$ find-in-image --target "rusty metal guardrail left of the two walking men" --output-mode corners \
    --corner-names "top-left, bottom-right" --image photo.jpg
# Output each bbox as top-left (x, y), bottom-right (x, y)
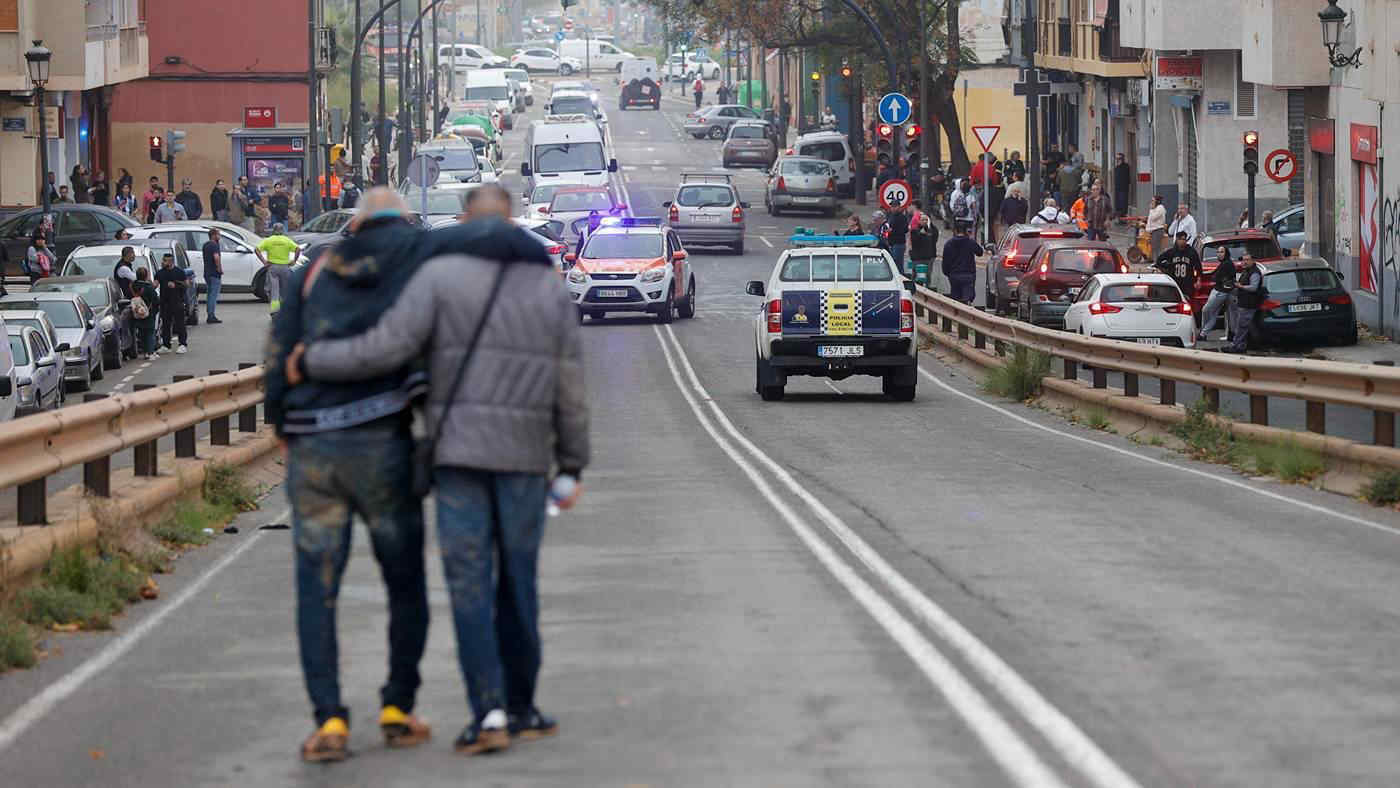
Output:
top-left (0, 364), bottom-right (263, 525)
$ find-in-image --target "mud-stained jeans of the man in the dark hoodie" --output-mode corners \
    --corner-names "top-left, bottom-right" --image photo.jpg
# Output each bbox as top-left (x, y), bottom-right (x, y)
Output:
top-left (287, 424), bottom-right (428, 725)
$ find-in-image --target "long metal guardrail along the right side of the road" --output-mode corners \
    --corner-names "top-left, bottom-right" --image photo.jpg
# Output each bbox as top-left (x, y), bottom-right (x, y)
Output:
top-left (914, 287), bottom-right (1400, 446)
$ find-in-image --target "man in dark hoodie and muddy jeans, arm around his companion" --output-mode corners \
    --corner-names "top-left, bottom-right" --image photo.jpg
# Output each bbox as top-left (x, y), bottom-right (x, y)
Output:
top-left (265, 186), bottom-right (557, 761)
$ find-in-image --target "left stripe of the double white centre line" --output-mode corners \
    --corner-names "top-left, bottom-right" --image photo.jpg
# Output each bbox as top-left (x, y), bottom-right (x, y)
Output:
top-left (652, 326), bottom-right (1064, 787)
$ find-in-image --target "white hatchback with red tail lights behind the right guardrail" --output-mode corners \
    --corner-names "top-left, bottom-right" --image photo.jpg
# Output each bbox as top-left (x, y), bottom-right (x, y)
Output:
top-left (1064, 273), bottom-right (1196, 347)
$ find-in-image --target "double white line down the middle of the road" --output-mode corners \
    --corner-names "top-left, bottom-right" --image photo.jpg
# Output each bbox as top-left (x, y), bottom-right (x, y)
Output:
top-left (652, 326), bottom-right (1138, 788)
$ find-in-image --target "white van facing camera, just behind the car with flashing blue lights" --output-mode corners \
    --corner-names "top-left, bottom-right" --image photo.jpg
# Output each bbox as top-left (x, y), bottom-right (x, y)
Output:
top-left (521, 115), bottom-right (617, 195)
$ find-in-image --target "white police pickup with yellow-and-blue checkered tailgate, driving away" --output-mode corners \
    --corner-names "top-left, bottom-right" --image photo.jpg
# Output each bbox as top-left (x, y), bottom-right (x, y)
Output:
top-left (748, 228), bottom-right (918, 402)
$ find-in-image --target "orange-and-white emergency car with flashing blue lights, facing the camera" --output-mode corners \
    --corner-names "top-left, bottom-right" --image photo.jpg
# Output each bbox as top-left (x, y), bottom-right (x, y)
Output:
top-left (564, 217), bottom-right (696, 323)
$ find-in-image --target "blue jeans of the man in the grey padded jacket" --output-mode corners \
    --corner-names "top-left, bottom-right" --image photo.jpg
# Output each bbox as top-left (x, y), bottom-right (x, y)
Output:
top-left (435, 466), bottom-right (549, 722)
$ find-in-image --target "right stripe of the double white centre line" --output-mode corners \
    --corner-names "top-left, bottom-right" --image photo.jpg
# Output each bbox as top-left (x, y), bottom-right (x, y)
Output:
top-left (658, 326), bottom-right (1138, 788)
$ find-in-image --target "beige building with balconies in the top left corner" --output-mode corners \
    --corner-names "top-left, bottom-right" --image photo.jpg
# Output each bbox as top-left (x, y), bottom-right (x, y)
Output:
top-left (0, 0), bottom-right (147, 209)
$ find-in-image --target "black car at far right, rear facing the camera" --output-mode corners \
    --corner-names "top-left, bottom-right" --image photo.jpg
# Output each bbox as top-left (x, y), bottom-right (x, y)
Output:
top-left (1252, 258), bottom-right (1357, 344)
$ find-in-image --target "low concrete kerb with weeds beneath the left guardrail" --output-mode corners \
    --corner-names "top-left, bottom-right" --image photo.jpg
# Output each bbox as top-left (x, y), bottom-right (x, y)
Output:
top-left (0, 430), bottom-right (277, 598)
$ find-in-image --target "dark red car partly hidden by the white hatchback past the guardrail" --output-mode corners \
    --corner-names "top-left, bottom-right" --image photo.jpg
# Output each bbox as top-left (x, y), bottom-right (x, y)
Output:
top-left (1016, 239), bottom-right (1128, 329)
